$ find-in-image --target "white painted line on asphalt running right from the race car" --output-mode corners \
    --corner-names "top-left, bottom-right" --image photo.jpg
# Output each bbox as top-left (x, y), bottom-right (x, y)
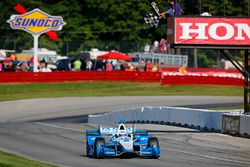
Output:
top-left (161, 148), bottom-right (250, 165)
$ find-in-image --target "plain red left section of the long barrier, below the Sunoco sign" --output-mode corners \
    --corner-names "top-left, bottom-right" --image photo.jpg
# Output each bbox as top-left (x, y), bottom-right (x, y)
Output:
top-left (0, 71), bottom-right (161, 83)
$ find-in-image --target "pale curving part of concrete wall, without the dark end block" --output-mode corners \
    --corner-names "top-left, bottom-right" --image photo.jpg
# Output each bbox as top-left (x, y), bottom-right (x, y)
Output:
top-left (88, 107), bottom-right (225, 130)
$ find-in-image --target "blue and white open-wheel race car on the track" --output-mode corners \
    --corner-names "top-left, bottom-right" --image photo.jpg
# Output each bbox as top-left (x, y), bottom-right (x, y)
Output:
top-left (86, 122), bottom-right (160, 159)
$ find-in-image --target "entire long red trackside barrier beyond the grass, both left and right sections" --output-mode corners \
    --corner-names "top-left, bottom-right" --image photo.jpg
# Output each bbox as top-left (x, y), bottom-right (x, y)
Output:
top-left (0, 71), bottom-right (244, 86)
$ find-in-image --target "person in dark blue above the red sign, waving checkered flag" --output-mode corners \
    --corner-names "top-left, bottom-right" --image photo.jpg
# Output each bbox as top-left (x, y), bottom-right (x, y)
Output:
top-left (160, 0), bottom-right (182, 18)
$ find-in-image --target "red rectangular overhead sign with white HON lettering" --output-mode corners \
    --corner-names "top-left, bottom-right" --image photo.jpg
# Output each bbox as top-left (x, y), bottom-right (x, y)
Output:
top-left (172, 17), bottom-right (250, 46)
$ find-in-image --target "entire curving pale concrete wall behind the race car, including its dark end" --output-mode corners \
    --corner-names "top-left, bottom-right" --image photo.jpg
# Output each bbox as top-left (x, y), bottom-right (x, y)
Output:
top-left (88, 106), bottom-right (250, 134)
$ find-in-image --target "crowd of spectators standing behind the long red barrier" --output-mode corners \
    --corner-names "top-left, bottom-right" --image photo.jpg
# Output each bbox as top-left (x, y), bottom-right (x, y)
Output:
top-left (0, 49), bottom-right (166, 72)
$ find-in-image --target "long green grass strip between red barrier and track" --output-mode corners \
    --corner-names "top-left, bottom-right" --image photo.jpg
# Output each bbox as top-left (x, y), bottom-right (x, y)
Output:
top-left (0, 82), bottom-right (243, 101)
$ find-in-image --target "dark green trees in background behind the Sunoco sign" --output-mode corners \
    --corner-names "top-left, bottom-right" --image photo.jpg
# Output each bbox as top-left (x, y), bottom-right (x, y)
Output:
top-left (0, 0), bottom-right (250, 54)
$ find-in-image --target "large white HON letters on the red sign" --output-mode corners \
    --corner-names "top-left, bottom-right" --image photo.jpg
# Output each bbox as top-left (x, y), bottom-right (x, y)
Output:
top-left (179, 23), bottom-right (250, 40)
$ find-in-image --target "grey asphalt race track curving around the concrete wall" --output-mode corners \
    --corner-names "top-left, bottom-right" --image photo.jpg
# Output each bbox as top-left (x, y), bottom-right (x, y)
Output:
top-left (0, 96), bottom-right (250, 167)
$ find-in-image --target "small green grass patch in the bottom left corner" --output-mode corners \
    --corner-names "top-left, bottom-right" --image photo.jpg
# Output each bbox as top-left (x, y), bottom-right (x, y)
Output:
top-left (0, 151), bottom-right (56, 167)
